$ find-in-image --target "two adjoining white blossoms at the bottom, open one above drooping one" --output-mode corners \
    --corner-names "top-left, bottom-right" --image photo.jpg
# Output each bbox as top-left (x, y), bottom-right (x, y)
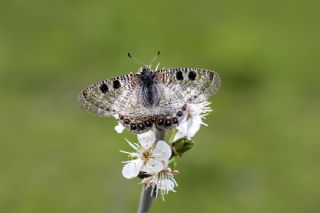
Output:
top-left (121, 131), bottom-right (177, 199)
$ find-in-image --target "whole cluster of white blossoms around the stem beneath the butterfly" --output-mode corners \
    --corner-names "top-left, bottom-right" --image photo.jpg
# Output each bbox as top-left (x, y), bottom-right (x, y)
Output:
top-left (115, 102), bottom-right (211, 197)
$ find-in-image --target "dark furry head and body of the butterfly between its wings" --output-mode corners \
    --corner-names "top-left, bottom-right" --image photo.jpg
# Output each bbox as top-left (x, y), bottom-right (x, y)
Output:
top-left (140, 67), bottom-right (160, 107)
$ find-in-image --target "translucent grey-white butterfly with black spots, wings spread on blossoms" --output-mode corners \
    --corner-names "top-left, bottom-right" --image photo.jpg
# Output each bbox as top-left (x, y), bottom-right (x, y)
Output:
top-left (78, 66), bottom-right (220, 134)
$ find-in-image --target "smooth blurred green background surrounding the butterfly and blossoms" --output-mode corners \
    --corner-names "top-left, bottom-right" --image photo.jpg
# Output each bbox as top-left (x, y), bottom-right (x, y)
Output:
top-left (0, 0), bottom-right (320, 213)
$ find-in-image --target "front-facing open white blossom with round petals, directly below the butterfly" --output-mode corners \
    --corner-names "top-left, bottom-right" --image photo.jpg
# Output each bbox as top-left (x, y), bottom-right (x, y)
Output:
top-left (121, 131), bottom-right (172, 179)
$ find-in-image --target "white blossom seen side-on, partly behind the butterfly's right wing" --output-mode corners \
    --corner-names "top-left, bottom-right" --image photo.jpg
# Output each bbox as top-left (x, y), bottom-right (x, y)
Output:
top-left (173, 101), bottom-right (212, 141)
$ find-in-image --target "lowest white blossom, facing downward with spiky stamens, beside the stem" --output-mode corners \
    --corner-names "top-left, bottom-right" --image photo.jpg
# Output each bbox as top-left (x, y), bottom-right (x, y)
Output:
top-left (142, 168), bottom-right (178, 200)
